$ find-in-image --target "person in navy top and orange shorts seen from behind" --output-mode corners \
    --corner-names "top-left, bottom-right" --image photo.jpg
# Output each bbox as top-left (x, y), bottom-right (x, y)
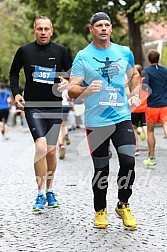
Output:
top-left (142, 49), bottom-right (167, 166)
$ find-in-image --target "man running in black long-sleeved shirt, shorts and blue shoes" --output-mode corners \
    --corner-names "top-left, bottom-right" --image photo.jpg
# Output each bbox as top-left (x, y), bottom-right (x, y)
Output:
top-left (10, 16), bottom-right (72, 211)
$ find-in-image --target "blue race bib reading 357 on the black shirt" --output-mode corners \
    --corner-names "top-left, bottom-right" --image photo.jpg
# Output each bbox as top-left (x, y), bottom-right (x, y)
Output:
top-left (33, 66), bottom-right (56, 84)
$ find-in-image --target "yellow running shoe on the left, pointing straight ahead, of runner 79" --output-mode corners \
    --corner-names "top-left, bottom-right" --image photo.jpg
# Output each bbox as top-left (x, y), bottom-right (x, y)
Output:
top-left (94, 208), bottom-right (108, 228)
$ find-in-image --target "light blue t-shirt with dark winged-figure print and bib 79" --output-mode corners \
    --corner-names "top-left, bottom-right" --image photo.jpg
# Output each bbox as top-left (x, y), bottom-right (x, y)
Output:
top-left (71, 43), bottom-right (134, 127)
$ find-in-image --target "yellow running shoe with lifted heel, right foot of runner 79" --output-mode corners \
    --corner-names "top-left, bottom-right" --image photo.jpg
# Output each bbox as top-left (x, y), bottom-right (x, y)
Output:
top-left (115, 204), bottom-right (137, 229)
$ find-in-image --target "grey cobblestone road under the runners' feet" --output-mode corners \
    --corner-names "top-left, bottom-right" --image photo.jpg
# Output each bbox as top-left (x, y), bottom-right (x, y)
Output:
top-left (0, 127), bottom-right (167, 252)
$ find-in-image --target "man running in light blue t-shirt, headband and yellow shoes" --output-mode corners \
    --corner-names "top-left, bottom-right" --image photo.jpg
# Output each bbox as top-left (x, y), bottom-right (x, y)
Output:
top-left (69, 12), bottom-right (140, 229)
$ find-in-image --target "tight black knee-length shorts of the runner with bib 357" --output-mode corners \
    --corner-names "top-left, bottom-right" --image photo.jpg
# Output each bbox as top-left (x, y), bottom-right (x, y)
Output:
top-left (25, 108), bottom-right (62, 145)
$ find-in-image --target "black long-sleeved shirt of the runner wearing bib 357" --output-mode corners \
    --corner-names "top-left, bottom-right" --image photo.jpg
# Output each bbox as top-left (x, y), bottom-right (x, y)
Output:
top-left (10, 42), bottom-right (72, 101)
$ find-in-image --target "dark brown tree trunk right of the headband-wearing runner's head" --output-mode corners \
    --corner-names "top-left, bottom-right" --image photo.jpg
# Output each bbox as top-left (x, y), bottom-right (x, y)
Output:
top-left (127, 13), bottom-right (143, 66)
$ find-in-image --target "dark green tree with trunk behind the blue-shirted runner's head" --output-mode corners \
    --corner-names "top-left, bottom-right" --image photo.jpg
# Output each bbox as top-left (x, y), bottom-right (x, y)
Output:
top-left (22, 0), bottom-right (167, 65)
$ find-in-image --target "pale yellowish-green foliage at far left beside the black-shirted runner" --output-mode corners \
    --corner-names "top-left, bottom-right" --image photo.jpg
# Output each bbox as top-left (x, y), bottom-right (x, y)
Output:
top-left (0, 0), bottom-right (33, 84)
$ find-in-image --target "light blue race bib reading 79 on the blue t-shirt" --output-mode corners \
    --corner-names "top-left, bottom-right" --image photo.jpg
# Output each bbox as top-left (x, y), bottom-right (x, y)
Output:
top-left (99, 87), bottom-right (124, 106)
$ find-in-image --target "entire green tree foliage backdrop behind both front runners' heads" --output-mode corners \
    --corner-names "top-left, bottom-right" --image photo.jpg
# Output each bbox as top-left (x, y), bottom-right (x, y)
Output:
top-left (0, 0), bottom-right (167, 83)
